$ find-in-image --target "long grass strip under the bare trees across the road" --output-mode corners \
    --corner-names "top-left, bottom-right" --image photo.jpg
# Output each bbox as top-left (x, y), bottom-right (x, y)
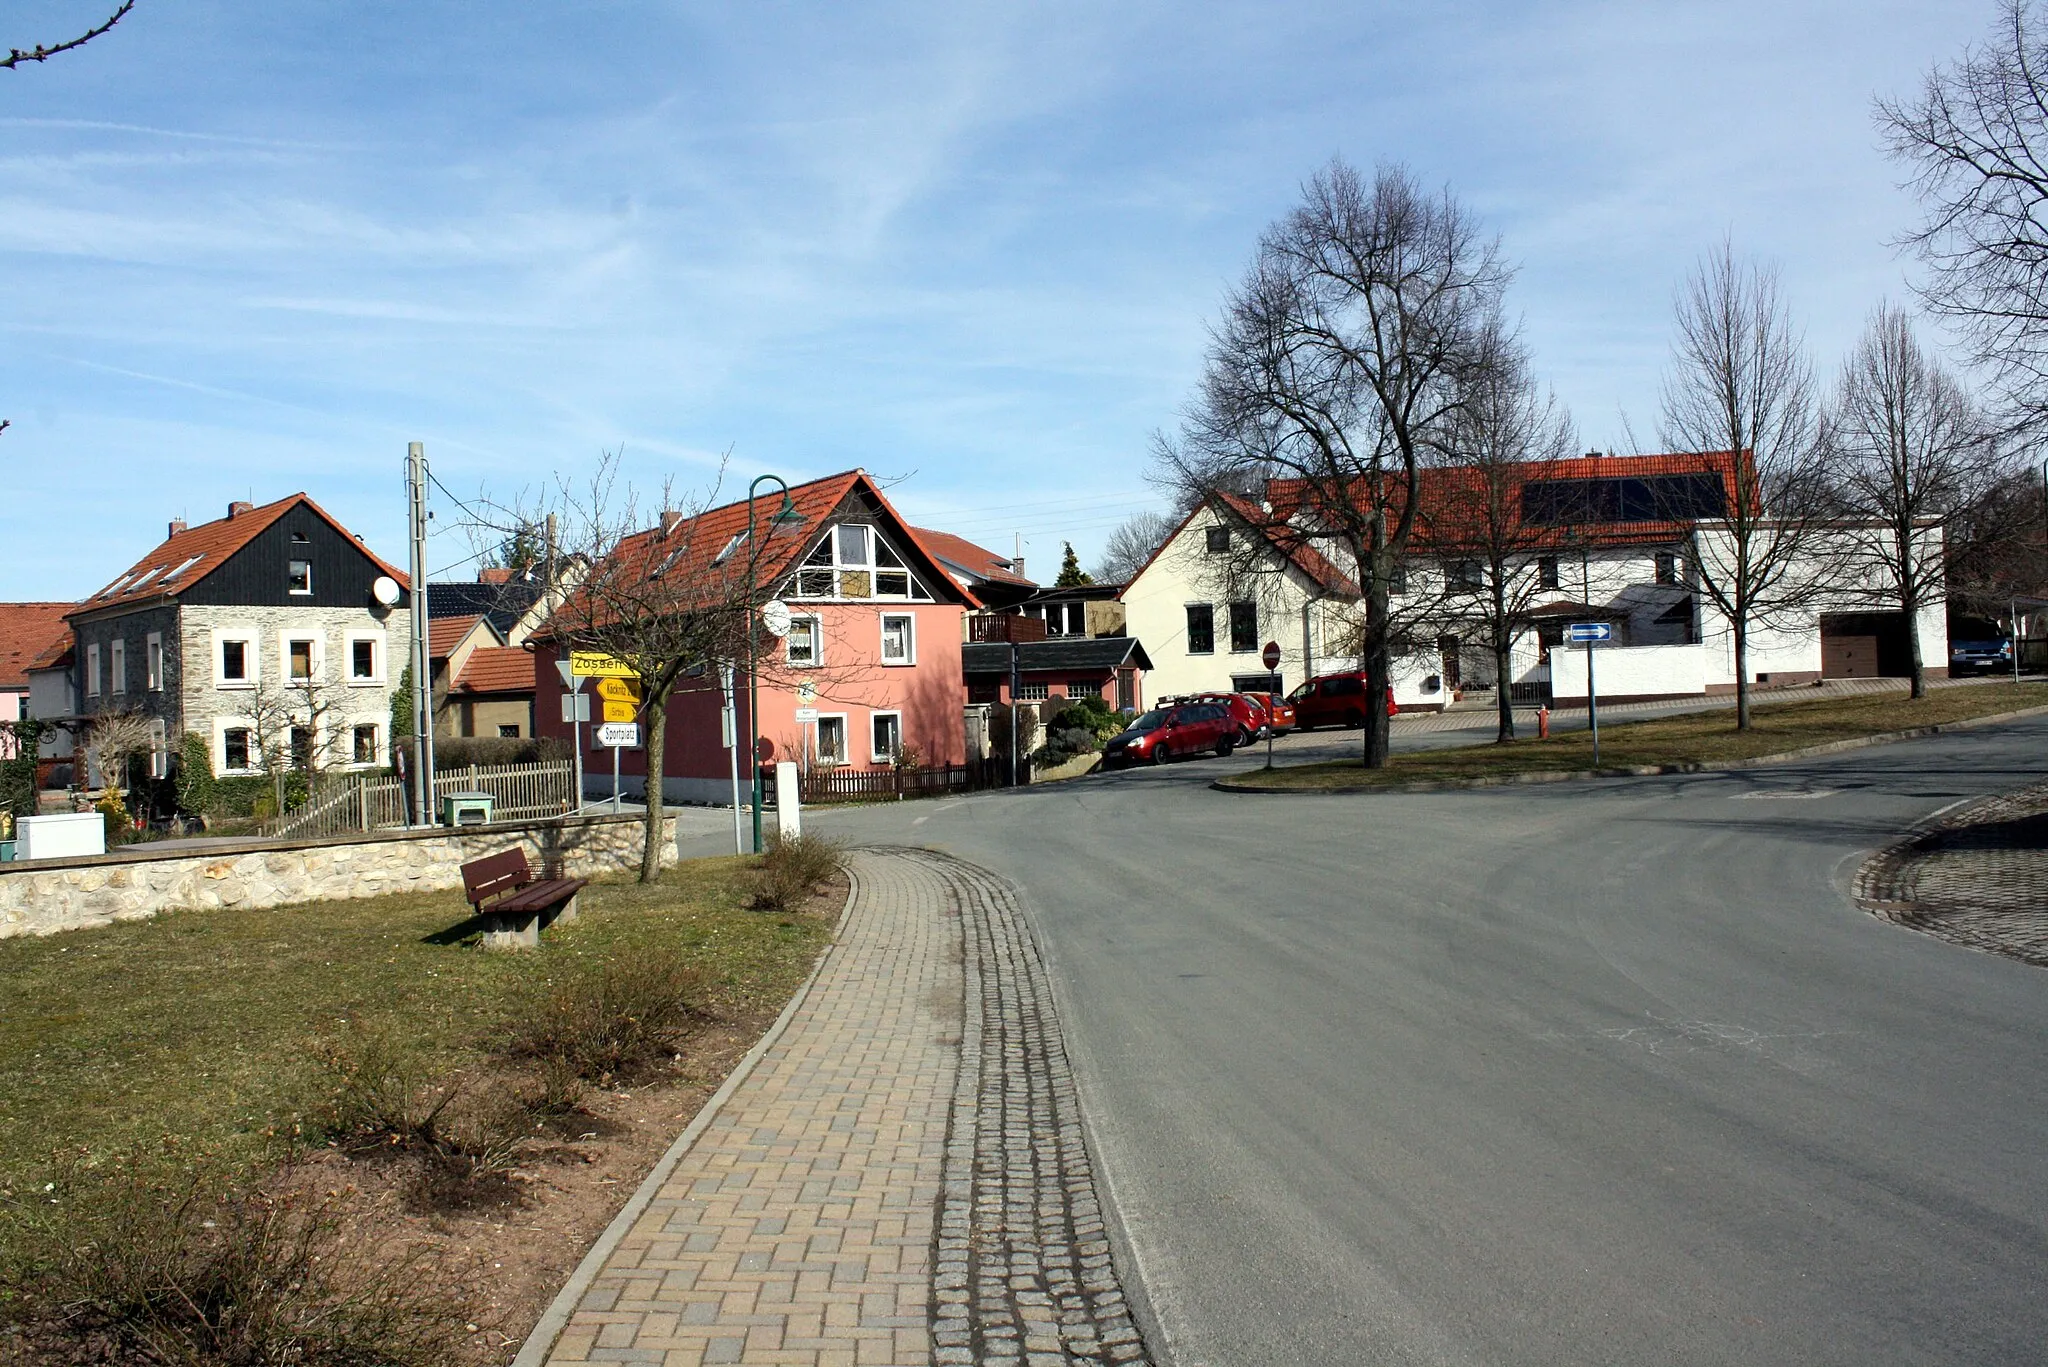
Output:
top-left (1229, 682), bottom-right (2048, 793)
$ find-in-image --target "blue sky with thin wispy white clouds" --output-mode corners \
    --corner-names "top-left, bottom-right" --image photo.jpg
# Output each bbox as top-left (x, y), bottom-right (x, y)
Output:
top-left (0, 0), bottom-right (1993, 598)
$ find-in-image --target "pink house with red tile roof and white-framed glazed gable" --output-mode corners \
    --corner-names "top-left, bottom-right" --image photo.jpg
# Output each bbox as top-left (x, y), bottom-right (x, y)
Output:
top-left (535, 469), bottom-right (977, 805)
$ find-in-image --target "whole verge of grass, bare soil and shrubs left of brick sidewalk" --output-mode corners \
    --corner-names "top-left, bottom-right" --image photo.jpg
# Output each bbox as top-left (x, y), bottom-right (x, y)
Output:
top-left (0, 859), bottom-right (836, 1367)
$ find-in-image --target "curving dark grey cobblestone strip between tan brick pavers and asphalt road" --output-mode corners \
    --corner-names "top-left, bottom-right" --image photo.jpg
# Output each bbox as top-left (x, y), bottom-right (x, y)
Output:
top-left (895, 851), bottom-right (1153, 1367)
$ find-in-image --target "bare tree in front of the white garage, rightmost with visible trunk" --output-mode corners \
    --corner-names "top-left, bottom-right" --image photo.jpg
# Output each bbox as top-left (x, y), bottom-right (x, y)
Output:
top-left (1823, 305), bottom-right (1999, 697)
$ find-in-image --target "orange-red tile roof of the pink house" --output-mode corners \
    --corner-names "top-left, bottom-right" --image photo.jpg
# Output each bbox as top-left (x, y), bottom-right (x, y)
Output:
top-left (543, 469), bottom-right (979, 635)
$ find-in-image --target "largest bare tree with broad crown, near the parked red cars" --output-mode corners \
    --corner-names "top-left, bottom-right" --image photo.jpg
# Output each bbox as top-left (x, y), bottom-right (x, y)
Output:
top-left (1161, 160), bottom-right (1509, 767)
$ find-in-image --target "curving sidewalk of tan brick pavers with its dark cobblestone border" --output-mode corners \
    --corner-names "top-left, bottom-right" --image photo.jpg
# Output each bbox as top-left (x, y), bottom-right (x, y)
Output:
top-left (522, 851), bottom-right (1145, 1367)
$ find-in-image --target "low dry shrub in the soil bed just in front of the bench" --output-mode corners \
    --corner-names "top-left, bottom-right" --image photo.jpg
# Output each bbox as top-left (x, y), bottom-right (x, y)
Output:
top-left (506, 949), bottom-right (702, 1094)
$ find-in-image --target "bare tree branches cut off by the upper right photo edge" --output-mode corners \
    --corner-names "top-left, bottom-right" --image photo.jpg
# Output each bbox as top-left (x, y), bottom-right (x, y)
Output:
top-left (1876, 0), bottom-right (2048, 426)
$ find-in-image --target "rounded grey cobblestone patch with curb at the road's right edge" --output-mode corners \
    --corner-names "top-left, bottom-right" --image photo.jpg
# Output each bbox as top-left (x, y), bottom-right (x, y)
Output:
top-left (1855, 783), bottom-right (2048, 967)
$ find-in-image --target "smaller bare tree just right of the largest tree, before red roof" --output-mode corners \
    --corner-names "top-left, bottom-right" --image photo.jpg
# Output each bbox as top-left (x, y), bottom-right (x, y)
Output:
top-left (1421, 314), bottom-right (1577, 740)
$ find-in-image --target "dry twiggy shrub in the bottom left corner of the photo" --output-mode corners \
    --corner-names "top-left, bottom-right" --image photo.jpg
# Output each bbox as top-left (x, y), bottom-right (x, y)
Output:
top-left (0, 1160), bottom-right (465, 1367)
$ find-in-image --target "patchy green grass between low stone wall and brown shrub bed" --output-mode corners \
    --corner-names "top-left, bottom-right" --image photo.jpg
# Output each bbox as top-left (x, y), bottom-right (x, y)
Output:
top-left (0, 859), bottom-right (829, 1191)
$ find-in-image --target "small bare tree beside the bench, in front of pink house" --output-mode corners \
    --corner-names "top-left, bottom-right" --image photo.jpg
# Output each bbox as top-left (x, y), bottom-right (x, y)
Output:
top-left (520, 451), bottom-right (770, 883)
